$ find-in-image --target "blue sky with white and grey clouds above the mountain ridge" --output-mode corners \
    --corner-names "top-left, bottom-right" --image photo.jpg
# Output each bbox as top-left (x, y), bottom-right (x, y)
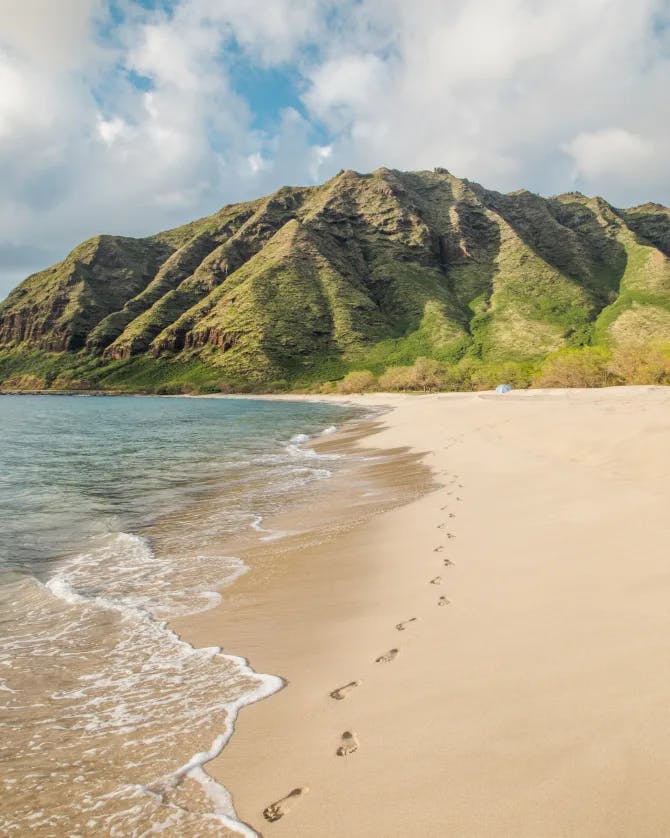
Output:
top-left (0, 0), bottom-right (670, 299)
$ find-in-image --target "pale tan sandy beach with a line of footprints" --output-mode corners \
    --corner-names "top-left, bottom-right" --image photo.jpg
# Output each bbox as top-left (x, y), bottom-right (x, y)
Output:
top-left (180, 387), bottom-right (670, 838)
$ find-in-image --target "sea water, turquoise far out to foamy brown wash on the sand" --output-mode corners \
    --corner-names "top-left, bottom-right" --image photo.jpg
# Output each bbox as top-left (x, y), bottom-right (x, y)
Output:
top-left (0, 396), bottom-right (368, 835)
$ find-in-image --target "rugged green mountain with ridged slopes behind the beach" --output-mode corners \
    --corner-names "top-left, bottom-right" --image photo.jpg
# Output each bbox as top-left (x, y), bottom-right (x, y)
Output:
top-left (0, 169), bottom-right (670, 390)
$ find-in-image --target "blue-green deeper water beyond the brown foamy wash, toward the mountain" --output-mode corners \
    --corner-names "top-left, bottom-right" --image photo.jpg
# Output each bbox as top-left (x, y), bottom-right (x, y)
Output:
top-left (0, 396), bottom-right (356, 574)
